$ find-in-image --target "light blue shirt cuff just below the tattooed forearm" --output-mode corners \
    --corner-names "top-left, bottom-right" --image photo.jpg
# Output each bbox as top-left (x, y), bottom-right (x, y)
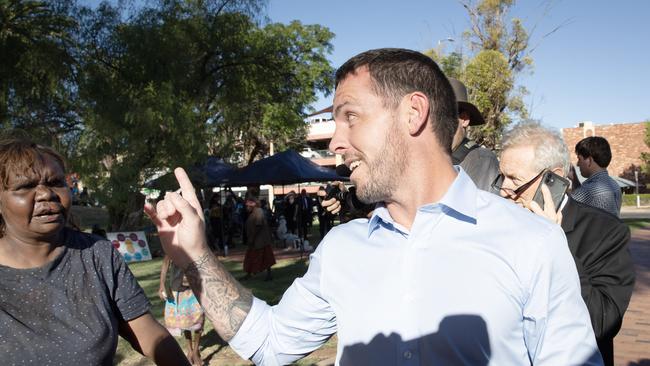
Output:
top-left (229, 297), bottom-right (271, 360)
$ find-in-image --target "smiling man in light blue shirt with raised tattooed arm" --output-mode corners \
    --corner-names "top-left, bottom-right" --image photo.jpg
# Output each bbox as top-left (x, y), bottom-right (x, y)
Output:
top-left (146, 49), bottom-right (602, 365)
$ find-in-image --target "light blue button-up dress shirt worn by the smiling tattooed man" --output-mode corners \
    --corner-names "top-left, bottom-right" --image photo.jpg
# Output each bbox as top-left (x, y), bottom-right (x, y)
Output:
top-left (230, 170), bottom-right (602, 366)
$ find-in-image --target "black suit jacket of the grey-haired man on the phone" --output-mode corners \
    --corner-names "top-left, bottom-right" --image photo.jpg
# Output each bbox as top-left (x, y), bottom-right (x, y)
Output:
top-left (562, 197), bottom-right (634, 365)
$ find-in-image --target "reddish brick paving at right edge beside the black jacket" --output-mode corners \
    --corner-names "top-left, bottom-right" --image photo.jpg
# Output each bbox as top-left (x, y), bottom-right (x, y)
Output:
top-left (614, 228), bottom-right (650, 366)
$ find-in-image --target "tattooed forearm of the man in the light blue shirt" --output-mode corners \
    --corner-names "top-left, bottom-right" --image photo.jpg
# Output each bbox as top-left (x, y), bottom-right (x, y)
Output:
top-left (185, 252), bottom-right (253, 342)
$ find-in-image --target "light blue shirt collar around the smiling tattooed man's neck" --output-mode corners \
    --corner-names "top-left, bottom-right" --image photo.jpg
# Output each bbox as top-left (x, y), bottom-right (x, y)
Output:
top-left (368, 166), bottom-right (478, 236)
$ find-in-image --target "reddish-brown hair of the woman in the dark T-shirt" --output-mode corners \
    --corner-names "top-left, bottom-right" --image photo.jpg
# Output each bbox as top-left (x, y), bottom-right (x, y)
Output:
top-left (0, 138), bottom-right (65, 237)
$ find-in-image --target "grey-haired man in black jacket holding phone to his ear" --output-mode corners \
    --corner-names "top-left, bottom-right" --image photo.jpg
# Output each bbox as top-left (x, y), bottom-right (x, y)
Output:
top-left (494, 122), bottom-right (634, 365)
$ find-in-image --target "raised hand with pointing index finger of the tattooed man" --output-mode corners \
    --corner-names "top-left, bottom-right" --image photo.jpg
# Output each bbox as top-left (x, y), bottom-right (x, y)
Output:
top-left (144, 168), bottom-right (210, 269)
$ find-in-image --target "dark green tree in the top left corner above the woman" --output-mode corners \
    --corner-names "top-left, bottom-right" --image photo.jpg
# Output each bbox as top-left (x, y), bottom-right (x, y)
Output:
top-left (0, 0), bottom-right (80, 152)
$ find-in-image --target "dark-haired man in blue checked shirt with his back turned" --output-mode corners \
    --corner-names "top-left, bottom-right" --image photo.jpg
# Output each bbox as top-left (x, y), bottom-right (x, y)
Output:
top-left (571, 136), bottom-right (622, 217)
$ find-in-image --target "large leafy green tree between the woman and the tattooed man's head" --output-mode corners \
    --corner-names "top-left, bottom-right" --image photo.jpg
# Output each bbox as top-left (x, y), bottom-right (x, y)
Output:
top-left (75, 0), bottom-right (332, 228)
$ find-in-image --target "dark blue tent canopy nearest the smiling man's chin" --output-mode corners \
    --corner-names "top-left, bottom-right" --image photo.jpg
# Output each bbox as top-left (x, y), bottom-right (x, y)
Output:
top-left (219, 149), bottom-right (348, 186)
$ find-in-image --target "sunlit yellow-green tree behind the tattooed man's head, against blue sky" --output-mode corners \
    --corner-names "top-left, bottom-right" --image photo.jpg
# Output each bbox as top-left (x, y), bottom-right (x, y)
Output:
top-left (425, 0), bottom-right (533, 148)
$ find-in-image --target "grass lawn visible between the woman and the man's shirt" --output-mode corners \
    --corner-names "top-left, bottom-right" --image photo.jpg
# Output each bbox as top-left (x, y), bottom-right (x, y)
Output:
top-left (115, 233), bottom-right (336, 365)
